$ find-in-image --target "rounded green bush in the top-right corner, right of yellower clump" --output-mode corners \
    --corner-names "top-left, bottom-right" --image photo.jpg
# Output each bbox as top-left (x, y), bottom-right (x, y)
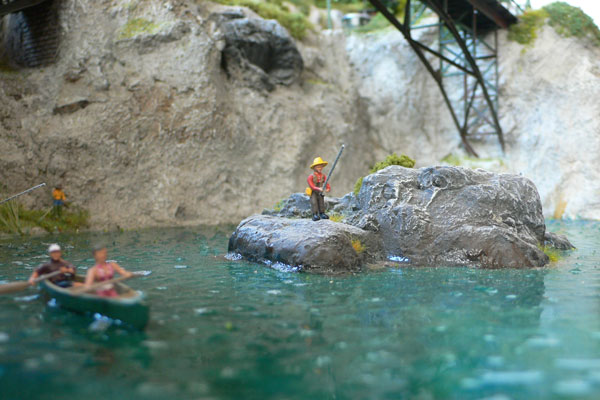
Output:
top-left (543, 1), bottom-right (600, 45)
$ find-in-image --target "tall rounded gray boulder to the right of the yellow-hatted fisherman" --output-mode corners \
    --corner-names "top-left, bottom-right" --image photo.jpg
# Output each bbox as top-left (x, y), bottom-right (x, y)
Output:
top-left (349, 166), bottom-right (548, 268)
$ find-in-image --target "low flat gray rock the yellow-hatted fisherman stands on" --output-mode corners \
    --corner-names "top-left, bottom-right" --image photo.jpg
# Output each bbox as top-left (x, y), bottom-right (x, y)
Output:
top-left (229, 215), bottom-right (381, 273)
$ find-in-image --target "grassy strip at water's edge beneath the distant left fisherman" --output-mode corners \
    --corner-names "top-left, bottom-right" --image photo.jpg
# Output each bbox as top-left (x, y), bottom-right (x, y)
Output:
top-left (0, 201), bottom-right (90, 235)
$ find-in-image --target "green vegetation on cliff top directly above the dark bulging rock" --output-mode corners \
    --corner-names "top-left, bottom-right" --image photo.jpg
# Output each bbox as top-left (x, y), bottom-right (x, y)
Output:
top-left (215, 0), bottom-right (313, 40)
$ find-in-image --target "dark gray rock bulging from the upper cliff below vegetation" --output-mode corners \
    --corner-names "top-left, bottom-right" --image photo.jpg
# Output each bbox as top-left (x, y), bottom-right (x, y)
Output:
top-left (213, 11), bottom-right (304, 91)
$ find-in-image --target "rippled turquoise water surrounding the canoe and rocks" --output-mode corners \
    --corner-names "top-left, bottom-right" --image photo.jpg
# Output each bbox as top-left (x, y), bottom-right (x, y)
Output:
top-left (0, 222), bottom-right (600, 400)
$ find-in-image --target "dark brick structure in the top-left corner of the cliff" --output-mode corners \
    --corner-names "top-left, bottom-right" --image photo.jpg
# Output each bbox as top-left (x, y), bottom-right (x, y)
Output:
top-left (0, 0), bottom-right (59, 67)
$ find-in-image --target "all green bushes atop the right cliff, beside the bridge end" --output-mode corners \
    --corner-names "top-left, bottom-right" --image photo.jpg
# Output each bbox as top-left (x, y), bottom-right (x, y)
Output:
top-left (508, 1), bottom-right (600, 45)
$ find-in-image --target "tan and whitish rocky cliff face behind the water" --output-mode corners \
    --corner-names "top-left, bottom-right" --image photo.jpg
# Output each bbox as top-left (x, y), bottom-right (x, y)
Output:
top-left (0, 0), bottom-right (600, 228)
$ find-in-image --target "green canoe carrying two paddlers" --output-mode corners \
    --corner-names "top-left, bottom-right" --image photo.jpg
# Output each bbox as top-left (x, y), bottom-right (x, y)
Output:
top-left (40, 276), bottom-right (150, 330)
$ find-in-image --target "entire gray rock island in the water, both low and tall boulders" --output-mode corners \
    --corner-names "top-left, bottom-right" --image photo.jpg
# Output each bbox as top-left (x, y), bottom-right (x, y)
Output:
top-left (229, 166), bottom-right (572, 270)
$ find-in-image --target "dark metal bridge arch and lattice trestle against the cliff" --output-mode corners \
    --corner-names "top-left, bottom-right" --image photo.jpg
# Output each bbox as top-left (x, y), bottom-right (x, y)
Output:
top-left (369, 0), bottom-right (522, 157)
